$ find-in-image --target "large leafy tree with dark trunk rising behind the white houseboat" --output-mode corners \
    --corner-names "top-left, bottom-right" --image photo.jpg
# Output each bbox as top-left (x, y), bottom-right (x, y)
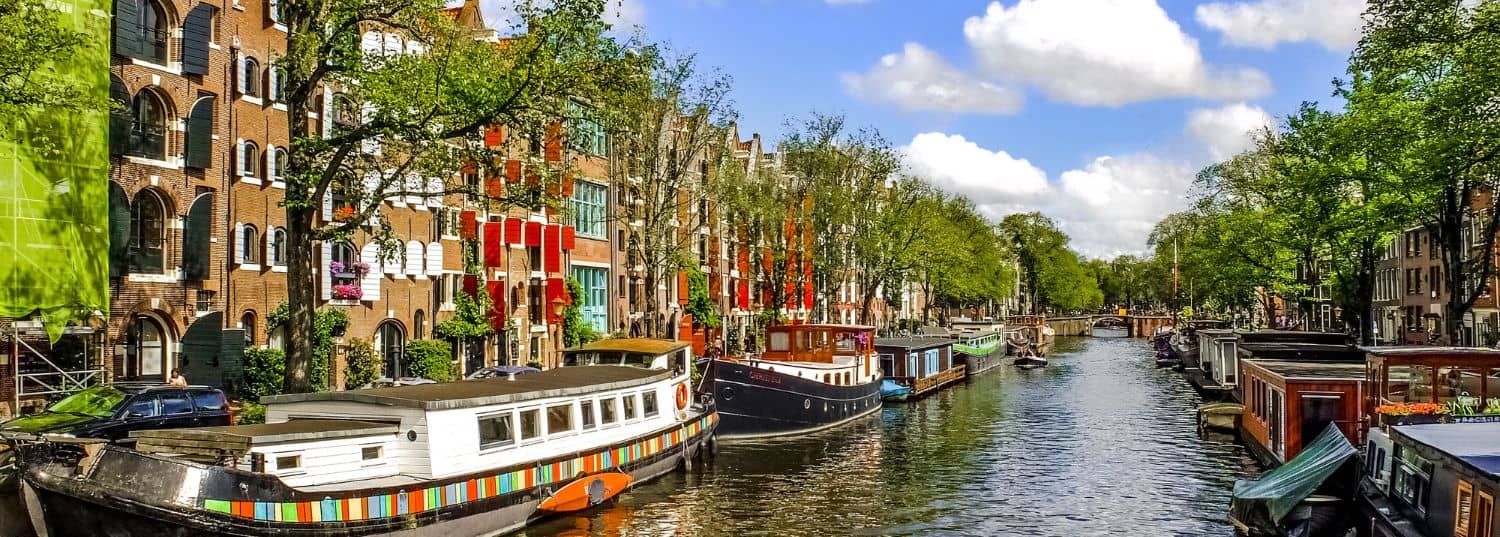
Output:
top-left (273, 0), bottom-right (626, 392)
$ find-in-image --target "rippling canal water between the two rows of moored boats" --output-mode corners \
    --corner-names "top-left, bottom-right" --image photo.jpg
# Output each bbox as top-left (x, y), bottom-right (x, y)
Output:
top-left (525, 330), bottom-right (1259, 536)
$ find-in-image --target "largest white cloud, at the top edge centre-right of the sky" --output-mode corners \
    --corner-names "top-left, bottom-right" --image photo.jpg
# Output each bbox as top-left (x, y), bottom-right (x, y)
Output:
top-left (963, 0), bottom-right (1271, 107)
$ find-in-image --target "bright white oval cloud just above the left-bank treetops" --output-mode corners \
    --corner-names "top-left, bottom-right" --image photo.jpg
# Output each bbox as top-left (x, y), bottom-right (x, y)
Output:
top-left (902, 132), bottom-right (1050, 206)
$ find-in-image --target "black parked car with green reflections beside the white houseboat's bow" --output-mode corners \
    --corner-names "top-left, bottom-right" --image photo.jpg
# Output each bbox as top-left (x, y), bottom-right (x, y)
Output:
top-left (0, 383), bottom-right (233, 441)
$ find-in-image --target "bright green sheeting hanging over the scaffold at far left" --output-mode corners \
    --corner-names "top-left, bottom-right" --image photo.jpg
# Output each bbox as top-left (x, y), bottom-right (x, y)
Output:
top-left (0, 0), bottom-right (109, 341)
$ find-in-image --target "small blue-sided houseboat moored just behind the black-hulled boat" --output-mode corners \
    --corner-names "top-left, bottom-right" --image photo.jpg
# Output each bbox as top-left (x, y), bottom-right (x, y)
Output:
top-left (875, 338), bottom-right (965, 401)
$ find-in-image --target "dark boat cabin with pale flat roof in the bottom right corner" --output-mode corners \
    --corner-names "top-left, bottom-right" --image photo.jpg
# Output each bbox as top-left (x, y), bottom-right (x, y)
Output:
top-left (1365, 423), bottom-right (1500, 537)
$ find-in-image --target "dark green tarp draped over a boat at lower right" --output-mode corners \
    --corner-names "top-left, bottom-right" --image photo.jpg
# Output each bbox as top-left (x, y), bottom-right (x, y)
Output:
top-left (1230, 423), bottom-right (1356, 524)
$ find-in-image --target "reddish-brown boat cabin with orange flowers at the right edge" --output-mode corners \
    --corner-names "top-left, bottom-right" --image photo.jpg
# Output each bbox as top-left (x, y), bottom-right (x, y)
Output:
top-left (1365, 347), bottom-right (1500, 422)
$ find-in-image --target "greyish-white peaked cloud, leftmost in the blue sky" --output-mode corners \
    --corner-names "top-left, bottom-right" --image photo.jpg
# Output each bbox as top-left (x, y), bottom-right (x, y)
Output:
top-left (843, 44), bottom-right (1025, 114)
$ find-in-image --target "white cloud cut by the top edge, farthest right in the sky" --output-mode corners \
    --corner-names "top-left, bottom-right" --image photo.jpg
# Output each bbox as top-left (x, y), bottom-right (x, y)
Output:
top-left (1197, 0), bottom-right (1365, 51)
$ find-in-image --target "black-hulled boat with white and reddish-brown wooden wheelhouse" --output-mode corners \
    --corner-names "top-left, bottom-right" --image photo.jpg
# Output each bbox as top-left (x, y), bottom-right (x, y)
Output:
top-left (707, 324), bottom-right (882, 438)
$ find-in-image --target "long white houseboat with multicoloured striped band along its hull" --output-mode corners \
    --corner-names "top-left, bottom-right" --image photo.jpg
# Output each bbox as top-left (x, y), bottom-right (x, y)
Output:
top-left (12, 339), bottom-right (717, 536)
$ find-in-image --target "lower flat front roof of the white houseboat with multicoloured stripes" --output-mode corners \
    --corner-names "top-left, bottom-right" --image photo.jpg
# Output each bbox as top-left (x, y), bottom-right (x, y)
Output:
top-left (131, 420), bottom-right (401, 444)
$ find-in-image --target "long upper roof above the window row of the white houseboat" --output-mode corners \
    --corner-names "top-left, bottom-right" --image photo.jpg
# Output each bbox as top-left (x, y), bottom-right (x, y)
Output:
top-left (261, 366), bottom-right (672, 411)
